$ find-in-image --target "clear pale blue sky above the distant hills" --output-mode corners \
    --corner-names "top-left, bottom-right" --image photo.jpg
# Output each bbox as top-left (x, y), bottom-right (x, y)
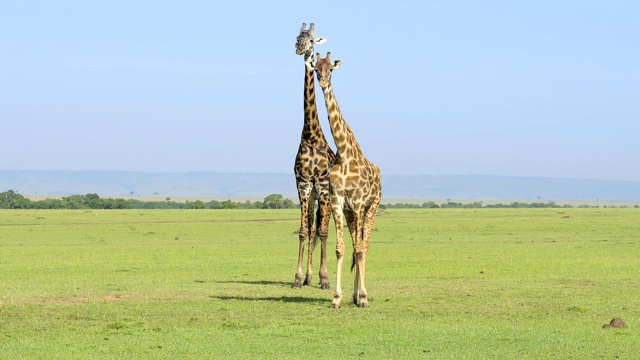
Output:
top-left (0, 0), bottom-right (640, 181)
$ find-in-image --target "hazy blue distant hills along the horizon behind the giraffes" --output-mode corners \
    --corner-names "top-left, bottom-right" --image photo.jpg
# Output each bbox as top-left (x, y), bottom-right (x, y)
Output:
top-left (0, 170), bottom-right (640, 202)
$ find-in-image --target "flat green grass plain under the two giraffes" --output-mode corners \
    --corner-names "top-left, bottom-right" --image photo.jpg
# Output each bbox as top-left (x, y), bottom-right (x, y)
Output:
top-left (0, 209), bottom-right (640, 359)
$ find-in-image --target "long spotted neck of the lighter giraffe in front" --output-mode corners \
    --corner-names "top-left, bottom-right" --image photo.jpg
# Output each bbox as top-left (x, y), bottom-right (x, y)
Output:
top-left (322, 84), bottom-right (363, 161)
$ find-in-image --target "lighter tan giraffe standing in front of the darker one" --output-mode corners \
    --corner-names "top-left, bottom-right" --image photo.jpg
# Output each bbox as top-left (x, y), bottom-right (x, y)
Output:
top-left (315, 53), bottom-right (382, 309)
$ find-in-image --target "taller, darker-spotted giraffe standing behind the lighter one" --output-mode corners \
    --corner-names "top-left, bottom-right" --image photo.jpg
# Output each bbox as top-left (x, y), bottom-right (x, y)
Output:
top-left (291, 24), bottom-right (335, 289)
